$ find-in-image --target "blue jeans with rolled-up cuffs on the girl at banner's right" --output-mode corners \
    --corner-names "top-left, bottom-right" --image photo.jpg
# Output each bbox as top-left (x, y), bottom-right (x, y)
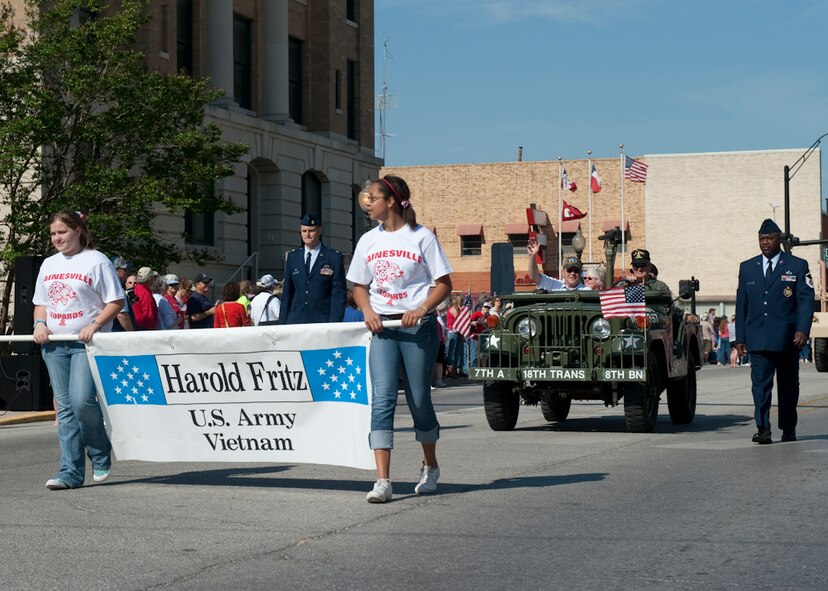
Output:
top-left (368, 316), bottom-right (440, 449)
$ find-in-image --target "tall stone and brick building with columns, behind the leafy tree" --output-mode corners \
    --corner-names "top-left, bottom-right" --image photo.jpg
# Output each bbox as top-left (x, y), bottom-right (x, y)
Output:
top-left (6, 0), bottom-right (381, 285)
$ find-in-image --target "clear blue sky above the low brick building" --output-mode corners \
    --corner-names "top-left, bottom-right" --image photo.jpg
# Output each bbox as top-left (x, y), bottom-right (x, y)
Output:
top-left (374, 0), bottom-right (828, 190)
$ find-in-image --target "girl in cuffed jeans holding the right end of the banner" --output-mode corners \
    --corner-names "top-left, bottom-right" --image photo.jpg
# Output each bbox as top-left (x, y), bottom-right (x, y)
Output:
top-left (347, 176), bottom-right (451, 503)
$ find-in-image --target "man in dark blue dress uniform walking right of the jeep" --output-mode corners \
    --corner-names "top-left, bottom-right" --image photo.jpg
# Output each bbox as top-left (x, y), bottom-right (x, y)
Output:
top-left (735, 219), bottom-right (814, 444)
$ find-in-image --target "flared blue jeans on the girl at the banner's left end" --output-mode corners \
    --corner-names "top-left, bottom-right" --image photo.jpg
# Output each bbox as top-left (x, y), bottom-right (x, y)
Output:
top-left (41, 342), bottom-right (112, 488)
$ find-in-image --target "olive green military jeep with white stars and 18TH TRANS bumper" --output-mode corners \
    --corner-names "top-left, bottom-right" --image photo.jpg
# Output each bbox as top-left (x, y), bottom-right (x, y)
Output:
top-left (476, 284), bottom-right (702, 433)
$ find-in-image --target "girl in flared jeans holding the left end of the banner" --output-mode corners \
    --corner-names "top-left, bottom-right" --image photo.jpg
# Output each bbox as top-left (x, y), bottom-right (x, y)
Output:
top-left (32, 210), bottom-right (126, 490)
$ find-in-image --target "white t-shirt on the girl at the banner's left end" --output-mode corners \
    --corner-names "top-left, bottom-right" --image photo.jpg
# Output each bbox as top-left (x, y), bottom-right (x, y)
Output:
top-left (32, 249), bottom-right (126, 334)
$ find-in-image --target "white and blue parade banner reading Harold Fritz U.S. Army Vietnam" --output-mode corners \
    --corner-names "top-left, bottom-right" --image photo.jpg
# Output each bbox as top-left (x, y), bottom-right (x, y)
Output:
top-left (87, 323), bottom-right (375, 469)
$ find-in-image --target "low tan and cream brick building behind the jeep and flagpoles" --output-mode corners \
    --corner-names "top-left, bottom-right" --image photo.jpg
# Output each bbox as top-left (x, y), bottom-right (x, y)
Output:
top-left (382, 149), bottom-right (825, 311)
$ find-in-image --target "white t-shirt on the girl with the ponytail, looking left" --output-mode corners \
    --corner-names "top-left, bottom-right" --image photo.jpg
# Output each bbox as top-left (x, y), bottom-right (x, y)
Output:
top-left (347, 224), bottom-right (451, 314)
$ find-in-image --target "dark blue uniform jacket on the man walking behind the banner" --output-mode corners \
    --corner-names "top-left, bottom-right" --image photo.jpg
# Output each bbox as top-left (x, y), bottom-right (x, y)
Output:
top-left (279, 244), bottom-right (347, 324)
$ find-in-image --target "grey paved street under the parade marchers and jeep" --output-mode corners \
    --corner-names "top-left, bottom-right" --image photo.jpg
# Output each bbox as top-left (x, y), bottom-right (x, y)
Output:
top-left (0, 365), bottom-right (828, 591)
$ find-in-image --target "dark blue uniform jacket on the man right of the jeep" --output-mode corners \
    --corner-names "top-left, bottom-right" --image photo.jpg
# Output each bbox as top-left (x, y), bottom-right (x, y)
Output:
top-left (736, 252), bottom-right (814, 351)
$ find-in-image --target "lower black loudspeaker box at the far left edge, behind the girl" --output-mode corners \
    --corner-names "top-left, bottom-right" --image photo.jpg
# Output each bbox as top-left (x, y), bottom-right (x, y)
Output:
top-left (0, 355), bottom-right (53, 410)
